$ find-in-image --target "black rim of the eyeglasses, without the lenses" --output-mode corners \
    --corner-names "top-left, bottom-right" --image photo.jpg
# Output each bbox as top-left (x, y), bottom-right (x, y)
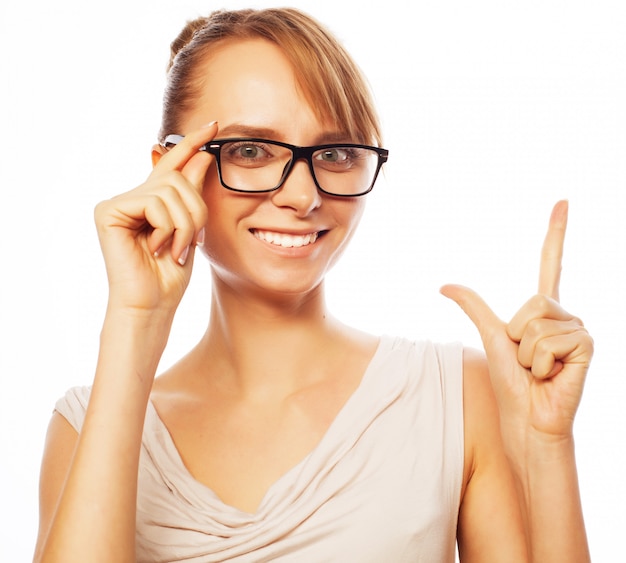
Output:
top-left (161, 134), bottom-right (389, 197)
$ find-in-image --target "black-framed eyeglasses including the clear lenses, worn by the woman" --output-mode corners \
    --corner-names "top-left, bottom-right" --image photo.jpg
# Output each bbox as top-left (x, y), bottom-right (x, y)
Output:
top-left (163, 135), bottom-right (389, 197)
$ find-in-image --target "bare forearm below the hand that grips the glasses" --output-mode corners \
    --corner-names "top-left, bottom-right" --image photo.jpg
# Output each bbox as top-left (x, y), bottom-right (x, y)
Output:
top-left (41, 312), bottom-right (171, 563)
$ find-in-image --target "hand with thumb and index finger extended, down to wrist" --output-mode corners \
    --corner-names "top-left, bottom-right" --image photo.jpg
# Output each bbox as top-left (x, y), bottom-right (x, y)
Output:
top-left (441, 201), bottom-right (593, 440)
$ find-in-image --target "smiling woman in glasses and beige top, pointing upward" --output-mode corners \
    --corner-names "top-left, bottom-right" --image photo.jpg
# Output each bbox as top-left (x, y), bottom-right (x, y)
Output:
top-left (35, 6), bottom-right (592, 563)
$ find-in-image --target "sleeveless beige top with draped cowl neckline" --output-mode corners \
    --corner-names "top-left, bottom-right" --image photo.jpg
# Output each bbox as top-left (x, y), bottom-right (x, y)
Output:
top-left (56, 337), bottom-right (463, 563)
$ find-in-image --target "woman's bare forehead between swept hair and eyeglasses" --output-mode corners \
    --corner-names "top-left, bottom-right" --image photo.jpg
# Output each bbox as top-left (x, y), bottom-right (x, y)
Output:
top-left (180, 39), bottom-right (327, 143)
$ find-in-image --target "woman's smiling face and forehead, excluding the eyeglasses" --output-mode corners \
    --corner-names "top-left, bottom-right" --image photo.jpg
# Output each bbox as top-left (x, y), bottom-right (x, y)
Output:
top-left (181, 39), bottom-right (365, 300)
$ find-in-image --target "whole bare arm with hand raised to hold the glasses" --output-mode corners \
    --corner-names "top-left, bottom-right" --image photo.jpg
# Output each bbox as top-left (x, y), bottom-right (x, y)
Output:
top-left (35, 124), bottom-right (217, 562)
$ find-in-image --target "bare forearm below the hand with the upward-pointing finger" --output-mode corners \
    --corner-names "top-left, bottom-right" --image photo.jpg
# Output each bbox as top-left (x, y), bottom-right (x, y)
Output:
top-left (509, 436), bottom-right (590, 563)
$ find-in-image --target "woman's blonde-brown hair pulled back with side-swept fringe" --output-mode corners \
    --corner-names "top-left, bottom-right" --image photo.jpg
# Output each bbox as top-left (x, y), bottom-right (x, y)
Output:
top-left (159, 8), bottom-right (382, 146)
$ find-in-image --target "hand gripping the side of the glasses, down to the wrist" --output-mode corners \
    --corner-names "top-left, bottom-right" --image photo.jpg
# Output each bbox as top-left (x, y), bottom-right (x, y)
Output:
top-left (95, 123), bottom-right (217, 315)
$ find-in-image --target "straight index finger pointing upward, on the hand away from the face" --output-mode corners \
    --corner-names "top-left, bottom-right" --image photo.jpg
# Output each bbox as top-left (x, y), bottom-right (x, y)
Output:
top-left (539, 200), bottom-right (568, 301)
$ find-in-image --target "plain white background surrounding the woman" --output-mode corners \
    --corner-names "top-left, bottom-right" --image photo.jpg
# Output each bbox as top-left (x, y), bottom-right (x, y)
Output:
top-left (0, 0), bottom-right (626, 562)
